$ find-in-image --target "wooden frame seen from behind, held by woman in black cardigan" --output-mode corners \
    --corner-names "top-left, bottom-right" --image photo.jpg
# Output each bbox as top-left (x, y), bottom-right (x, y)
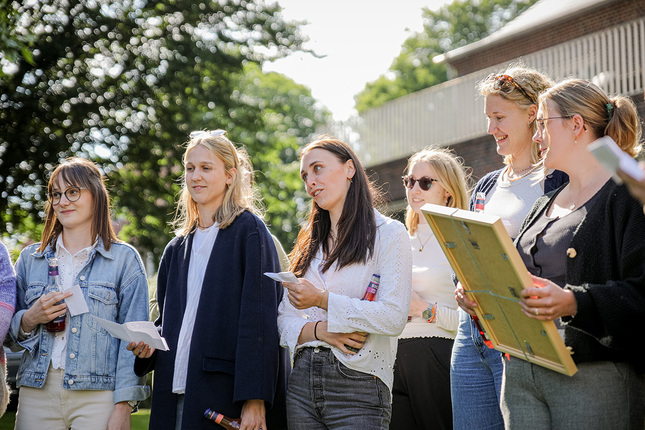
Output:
top-left (421, 204), bottom-right (578, 376)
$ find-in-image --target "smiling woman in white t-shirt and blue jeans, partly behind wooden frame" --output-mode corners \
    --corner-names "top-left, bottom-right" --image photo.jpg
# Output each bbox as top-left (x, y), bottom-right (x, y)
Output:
top-left (450, 67), bottom-right (566, 429)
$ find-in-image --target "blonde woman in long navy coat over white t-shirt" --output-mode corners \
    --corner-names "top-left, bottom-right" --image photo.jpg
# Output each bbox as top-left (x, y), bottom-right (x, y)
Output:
top-left (128, 130), bottom-right (289, 430)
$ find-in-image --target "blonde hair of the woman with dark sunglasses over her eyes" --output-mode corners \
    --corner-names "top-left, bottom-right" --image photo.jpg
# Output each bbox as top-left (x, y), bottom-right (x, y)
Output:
top-left (404, 146), bottom-right (470, 234)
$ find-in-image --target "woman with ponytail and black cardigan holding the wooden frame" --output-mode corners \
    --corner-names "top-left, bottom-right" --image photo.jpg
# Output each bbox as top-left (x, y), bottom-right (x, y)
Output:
top-left (502, 80), bottom-right (645, 429)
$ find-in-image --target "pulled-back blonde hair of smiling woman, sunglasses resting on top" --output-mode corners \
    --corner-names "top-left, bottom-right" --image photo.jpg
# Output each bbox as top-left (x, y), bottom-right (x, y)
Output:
top-left (477, 64), bottom-right (554, 165)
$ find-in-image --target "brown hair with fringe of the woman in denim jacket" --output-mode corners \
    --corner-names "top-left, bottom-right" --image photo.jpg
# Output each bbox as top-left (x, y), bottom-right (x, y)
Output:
top-left (38, 158), bottom-right (119, 252)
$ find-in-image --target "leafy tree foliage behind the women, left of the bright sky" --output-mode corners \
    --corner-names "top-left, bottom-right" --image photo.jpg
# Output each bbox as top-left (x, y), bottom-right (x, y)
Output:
top-left (0, 0), bottom-right (324, 264)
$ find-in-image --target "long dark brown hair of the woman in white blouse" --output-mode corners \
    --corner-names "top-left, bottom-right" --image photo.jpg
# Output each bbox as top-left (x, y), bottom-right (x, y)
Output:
top-left (289, 137), bottom-right (378, 276)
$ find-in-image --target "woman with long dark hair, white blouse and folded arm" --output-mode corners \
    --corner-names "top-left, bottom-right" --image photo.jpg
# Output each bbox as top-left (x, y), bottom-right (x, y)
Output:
top-left (278, 138), bottom-right (411, 430)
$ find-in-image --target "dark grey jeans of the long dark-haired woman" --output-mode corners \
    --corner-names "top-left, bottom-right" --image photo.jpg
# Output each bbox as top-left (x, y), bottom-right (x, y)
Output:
top-left (287, 347), bottom-right (392, 430)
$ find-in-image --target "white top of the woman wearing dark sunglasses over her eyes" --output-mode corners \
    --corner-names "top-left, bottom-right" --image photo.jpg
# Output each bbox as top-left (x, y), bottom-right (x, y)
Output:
top-left (399, 224), bottom-right (459, 339)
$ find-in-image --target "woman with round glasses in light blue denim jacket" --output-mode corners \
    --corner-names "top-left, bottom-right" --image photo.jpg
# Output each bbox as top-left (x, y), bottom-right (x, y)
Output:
top-left (10, 158), bottom-right (149, 430)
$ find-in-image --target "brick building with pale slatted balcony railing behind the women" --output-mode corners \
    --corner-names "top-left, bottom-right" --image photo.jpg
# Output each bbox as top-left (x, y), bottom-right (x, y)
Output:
top-left (330, 0), bottom-right (645, 212)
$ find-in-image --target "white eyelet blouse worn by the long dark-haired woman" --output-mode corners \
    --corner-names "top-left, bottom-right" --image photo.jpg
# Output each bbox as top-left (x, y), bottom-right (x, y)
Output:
top-left (278, 211), bottom-right (412, 390)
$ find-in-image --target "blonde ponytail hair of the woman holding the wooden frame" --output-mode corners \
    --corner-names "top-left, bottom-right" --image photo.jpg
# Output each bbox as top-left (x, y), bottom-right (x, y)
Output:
top-left (540, 79), bottom-right (642, 157)
